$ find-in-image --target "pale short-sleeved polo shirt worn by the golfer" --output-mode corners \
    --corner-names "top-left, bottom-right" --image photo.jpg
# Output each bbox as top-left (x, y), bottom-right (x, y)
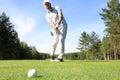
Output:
top-left (45, 6), bottom-right (67, 25)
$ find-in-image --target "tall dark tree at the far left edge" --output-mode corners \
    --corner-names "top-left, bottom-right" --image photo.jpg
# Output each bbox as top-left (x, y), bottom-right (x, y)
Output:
top-left (0, 12), bottom-right (19, 59)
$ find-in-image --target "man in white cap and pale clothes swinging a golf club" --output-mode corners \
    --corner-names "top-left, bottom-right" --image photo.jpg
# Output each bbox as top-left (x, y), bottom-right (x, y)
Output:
top-left (44, 0), bottom-right (67, 62)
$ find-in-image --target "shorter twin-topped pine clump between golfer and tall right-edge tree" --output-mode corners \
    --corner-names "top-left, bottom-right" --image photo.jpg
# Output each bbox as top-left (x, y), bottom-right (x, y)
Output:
top-left (77, 32), bottom-right (101, 59)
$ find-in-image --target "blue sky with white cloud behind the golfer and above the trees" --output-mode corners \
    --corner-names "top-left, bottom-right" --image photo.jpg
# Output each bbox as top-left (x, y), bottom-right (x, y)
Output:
top-left (0, 0), bottom-right (109, 53)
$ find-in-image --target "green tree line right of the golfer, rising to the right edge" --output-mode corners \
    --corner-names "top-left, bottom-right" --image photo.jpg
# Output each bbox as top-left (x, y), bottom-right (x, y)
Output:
top-left (65, 0), bottom-right (120, 60)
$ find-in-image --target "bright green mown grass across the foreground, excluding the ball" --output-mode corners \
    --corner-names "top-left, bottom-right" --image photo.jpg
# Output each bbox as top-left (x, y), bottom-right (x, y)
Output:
top-left (0, 60), bottom-right (120, 80)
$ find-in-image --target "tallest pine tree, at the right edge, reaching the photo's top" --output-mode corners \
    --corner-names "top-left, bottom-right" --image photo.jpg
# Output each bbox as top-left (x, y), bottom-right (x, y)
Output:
top-left (100, 0), bottom-right (120, 59)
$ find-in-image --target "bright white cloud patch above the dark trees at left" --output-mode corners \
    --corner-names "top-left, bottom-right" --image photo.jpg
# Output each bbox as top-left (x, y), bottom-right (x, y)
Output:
top-left (11, 13), bottom-right (35, 37)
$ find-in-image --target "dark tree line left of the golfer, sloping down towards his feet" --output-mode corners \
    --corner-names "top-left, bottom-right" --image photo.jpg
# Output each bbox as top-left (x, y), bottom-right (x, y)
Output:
top-left (0, 12), bottom-right (49, 60)
